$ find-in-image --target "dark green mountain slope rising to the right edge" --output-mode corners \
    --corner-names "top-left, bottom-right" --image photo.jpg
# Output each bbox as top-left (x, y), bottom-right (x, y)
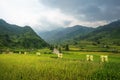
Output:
top-left (79, 20), bottom-right (120, 45)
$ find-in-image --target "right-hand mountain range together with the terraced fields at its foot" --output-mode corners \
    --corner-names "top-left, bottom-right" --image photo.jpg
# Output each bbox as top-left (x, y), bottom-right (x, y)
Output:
top-left (41, 20), bottom-right (120, 52)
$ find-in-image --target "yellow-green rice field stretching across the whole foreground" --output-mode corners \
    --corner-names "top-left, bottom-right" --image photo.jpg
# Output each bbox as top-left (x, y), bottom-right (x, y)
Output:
top-left (0, 50), bottom-right (120, 80)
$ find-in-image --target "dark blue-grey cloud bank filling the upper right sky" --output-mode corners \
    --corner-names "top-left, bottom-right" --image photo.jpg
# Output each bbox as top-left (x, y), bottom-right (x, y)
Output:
top-left (42, 0), bottom-right (120, 21)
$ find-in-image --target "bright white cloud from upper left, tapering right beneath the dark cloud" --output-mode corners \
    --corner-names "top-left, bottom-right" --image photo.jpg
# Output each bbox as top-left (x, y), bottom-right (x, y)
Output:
top-left (0, 0), bottom-right (106, 30)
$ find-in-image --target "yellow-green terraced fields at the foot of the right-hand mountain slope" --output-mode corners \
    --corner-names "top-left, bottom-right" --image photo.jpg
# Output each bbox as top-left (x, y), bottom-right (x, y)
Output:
top-left (69, 41), bottom-right (120, 54)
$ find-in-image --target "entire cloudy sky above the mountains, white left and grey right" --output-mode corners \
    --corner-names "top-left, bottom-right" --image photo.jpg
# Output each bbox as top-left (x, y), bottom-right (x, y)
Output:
top-left (0, 0), bottom-right (120, 31)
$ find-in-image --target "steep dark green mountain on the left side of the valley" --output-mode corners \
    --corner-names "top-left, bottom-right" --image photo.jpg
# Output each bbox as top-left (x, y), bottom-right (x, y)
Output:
top-left (0, 19), bottom-right (47, 48)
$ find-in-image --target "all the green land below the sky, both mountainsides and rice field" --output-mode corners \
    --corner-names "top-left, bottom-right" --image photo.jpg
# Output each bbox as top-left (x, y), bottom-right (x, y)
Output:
top-left (0, 20), bottom-right (120, 80)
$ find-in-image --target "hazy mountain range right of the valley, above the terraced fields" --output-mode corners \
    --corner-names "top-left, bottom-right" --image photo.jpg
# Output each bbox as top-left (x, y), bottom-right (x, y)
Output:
top-left (39, 20), bottom-right (120, 45)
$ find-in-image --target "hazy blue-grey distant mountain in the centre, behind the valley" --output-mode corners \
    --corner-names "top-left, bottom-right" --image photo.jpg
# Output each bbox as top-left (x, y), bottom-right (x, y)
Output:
top-left (39, 25), bottom-right (94, 43)
